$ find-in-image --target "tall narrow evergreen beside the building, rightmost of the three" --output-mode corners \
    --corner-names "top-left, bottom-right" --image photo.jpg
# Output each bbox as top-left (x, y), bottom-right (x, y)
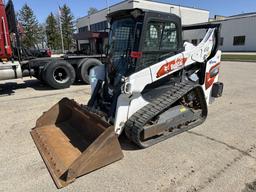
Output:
top-left (61, 4), bottom-right (75, 50)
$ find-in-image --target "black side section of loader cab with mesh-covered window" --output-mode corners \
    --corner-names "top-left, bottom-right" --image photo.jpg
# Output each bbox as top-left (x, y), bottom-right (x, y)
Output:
top-left (133, 13), bottom-right (183, 71)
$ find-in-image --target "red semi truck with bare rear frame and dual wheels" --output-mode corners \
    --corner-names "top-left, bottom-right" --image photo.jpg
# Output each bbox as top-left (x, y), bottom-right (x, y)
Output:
top-left (0, 0), bottom-right (106, 89)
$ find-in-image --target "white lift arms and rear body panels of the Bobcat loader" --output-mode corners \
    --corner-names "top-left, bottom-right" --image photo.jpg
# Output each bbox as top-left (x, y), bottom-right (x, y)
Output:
top-left (90, 29), bottom-right (221, 135)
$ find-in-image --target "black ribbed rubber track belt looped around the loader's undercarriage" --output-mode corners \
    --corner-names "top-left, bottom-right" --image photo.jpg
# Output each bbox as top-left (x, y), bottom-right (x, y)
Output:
top-left (125, 82), bottom-right (207, 148)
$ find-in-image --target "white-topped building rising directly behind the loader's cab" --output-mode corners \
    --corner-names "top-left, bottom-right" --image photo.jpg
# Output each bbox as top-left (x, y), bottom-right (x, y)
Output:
top-left (77, 0), bottom-right (209, 49)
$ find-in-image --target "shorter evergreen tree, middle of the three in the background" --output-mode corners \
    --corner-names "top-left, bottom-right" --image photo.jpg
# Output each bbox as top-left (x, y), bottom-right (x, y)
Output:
top-left (45, 13), bottom-right (61, 50)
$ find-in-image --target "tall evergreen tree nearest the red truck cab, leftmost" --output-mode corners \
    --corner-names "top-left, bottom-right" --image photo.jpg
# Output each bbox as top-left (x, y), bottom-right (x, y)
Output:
top-left (18, 4), bottom-right (39, 48)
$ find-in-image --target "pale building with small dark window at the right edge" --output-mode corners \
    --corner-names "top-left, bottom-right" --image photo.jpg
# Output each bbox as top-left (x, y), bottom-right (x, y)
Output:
top-left (184, 12), bottom-right (256, 52)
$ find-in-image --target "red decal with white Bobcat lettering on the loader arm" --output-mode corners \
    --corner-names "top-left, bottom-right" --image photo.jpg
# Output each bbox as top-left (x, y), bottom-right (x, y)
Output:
top-left (156, 58), bottom-right (187, 78)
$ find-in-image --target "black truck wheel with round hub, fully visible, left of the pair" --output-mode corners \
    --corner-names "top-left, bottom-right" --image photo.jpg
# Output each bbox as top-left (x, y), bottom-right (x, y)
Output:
top-left (43, 61), bottom-right (76, 89)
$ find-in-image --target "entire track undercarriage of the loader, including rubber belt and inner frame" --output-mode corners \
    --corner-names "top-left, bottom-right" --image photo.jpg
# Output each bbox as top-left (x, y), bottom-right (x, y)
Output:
top-left (125, 83), bottom-right (207, 148)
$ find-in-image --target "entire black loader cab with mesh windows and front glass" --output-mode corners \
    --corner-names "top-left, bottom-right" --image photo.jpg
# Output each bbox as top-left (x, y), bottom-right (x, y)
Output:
top-left (107, 9), bottom-right (183, 85)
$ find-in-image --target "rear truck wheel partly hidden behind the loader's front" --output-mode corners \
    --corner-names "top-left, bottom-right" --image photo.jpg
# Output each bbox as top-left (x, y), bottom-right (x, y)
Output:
top-left (78, 59), bottom-right (102, 84)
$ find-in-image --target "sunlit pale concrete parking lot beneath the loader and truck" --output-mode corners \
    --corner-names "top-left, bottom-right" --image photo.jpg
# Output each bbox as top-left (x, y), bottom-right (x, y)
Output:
top-left (0, 62), bottom-right (256, 192)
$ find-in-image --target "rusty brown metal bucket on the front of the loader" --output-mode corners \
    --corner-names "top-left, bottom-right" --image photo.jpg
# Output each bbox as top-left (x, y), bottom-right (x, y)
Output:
top-left (31, 98), bottom-right (123, 188)
